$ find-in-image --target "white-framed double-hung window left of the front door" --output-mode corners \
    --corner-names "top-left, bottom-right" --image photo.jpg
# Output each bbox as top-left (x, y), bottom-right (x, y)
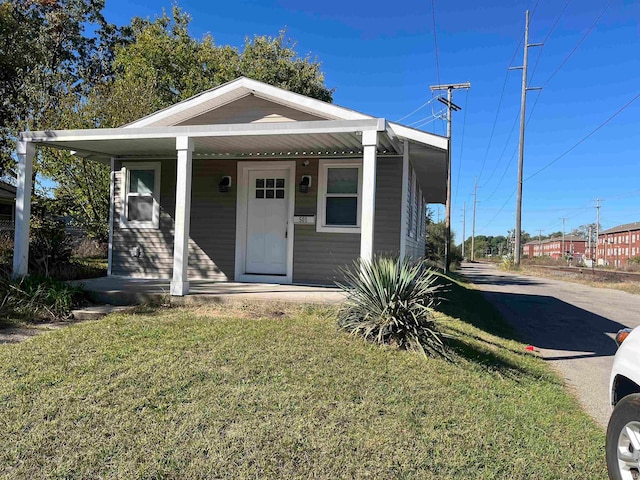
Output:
top-left (120, 162), bottom-right (160, 228)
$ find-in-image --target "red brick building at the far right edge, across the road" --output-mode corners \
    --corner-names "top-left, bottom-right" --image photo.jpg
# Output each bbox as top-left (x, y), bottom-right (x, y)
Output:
top-left (597, 222), bottom-right (640, 267)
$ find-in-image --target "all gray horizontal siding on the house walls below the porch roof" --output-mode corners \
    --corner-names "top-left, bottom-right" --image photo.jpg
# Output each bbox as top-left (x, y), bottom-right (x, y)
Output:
top-left (112, 157), bottom-right (402, 285)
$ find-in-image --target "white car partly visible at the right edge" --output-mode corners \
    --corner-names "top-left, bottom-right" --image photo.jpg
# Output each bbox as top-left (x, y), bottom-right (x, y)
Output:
top-left (606, 327), bottom-right (640, 480)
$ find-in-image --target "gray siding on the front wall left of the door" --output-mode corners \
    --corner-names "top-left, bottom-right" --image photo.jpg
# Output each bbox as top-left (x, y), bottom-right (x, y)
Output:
top-left (112, 159), bottom-right (237, 280)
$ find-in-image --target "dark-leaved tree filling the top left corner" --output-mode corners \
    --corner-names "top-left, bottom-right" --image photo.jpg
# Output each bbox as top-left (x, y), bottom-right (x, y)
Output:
top-left (0, 0), bottom-right (127, 174)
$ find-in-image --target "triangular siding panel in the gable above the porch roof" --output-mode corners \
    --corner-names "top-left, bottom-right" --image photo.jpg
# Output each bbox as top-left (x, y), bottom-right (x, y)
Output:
top-left (178, 95), bottom-right (324, 125)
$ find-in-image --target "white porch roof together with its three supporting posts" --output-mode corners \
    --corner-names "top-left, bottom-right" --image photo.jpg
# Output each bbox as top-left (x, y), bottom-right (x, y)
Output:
top-left (13, 118), bottom-right (446, 296)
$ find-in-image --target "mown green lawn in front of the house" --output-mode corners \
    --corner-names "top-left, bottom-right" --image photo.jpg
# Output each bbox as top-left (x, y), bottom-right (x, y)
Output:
top-left (0, 283), bottom-right (606, 480)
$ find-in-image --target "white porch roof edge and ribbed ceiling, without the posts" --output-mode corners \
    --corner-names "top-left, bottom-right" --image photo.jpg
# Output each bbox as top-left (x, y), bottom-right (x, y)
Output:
top-left (21, 118), bottom-right (447, 203)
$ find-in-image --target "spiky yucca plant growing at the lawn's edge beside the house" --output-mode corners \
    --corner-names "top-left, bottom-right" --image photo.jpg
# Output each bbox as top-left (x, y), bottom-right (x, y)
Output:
top-left (336, 256), bottom-right (448, 357)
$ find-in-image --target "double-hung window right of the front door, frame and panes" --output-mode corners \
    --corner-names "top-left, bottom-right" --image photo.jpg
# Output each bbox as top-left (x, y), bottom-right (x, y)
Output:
top-left (316, 160), bottom-right (362, 233)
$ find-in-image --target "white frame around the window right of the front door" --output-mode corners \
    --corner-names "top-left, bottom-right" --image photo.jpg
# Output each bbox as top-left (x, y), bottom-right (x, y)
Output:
top-left (316, 159), bottom-right (362, 233)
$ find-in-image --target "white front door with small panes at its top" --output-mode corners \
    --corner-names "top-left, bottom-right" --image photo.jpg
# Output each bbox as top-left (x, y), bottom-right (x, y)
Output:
top-left (245, 169), bottom-right (290, 276)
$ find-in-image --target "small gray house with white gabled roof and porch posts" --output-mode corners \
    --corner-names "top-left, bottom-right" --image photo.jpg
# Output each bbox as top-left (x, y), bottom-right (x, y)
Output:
top-left (14, 78), bottom-right (447, 295)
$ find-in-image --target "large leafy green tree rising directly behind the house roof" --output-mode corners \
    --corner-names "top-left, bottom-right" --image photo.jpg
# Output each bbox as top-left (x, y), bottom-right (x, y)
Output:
top-left (28, 6), bottom-right (333, 239)
